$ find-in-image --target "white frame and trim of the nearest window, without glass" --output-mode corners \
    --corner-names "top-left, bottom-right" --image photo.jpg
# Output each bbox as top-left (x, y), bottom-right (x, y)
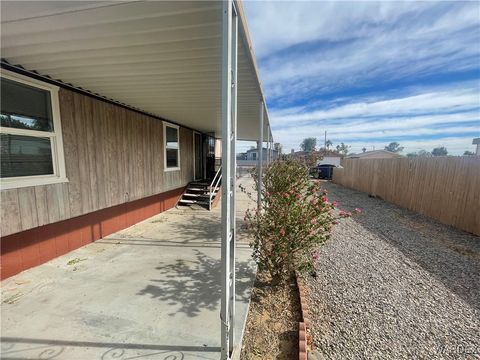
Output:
top-left (0, 69), bottom-right (68, 190)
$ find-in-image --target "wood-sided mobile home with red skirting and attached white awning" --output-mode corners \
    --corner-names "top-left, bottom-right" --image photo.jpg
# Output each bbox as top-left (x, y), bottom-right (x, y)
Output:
top-left (1, 1), bottom-right (271, 278)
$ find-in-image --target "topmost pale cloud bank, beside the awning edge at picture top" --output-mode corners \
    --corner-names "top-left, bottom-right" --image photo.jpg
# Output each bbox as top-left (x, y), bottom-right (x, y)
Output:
top-left (245, 0), bottom-right (431, 57)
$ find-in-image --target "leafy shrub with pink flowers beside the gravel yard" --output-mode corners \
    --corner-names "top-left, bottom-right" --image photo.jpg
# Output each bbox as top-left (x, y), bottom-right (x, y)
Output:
top-left (245, 159), bottom-right (360, 282)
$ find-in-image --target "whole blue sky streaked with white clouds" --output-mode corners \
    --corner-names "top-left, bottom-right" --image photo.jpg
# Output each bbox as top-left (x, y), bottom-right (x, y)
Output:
top-left (243, 1), bottom-right (480, 154)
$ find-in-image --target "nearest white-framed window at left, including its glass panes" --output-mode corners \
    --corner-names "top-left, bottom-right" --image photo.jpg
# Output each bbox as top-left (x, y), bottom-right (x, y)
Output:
top-left (0, 70), bottom-right (67, 189)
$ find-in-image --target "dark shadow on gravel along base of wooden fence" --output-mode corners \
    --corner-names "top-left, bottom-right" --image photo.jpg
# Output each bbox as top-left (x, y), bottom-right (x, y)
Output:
top-left (325, 183), bottom-right (480, 310)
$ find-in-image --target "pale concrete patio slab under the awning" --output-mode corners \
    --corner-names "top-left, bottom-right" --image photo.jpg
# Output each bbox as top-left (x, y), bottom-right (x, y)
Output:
top-left (1, 179), bottom-right (255, 360)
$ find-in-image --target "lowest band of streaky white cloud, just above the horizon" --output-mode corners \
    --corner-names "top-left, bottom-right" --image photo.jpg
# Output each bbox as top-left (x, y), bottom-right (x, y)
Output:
top-left (270, 87), bottom-right (480, 153)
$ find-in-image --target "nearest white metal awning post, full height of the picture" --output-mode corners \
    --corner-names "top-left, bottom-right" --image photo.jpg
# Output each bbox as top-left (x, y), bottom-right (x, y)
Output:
top-left (220, 0), bottom-right (238, 360)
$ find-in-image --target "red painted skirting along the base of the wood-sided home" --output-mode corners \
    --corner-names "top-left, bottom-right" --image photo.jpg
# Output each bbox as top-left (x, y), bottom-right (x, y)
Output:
top-left (0, 188), bottom-right (184, 280)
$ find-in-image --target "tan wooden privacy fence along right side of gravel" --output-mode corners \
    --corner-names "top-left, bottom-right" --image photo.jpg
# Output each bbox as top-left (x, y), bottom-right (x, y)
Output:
top-left (333, 156), bottom-right (480, 235)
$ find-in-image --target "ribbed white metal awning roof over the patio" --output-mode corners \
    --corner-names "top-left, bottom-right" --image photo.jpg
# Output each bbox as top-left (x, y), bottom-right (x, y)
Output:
top-left (1, 1), bottom-right (271, 141)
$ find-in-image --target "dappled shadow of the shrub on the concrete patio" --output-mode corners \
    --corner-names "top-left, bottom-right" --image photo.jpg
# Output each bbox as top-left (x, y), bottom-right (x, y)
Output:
top-left (138, 249), bottom-right (255, 317)
